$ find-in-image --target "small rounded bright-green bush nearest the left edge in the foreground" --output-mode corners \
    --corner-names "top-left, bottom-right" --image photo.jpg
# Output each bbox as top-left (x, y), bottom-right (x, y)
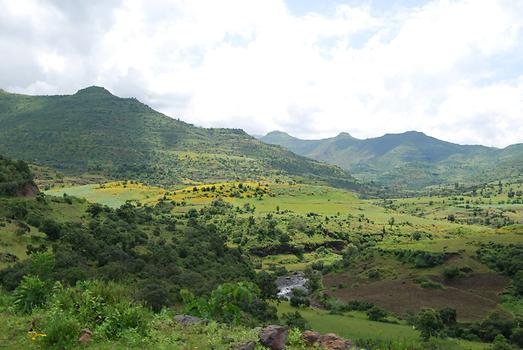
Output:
top-left (14, 276), bottom-right (49, 314)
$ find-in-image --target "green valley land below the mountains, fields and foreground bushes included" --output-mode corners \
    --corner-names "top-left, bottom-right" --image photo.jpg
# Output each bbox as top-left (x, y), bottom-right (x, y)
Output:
top-left (0, 153), bottom-right (523, 350)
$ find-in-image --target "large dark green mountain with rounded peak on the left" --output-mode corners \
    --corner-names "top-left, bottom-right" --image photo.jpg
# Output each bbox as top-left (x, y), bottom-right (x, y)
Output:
top-left (0, 86), bottom-right (359, 188)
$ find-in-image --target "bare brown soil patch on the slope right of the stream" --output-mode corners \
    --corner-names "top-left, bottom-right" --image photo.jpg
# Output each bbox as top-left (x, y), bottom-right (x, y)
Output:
top-left (324, 273), bottom-right (509, 320)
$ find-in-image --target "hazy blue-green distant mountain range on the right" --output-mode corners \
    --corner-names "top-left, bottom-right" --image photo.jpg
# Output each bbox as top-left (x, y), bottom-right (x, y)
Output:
top-left (260, 131), bottom-right (523, 189)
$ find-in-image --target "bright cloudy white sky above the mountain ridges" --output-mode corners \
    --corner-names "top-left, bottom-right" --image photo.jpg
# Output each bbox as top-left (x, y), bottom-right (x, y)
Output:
top-left (0, 0), bottom-right (523, 147)
